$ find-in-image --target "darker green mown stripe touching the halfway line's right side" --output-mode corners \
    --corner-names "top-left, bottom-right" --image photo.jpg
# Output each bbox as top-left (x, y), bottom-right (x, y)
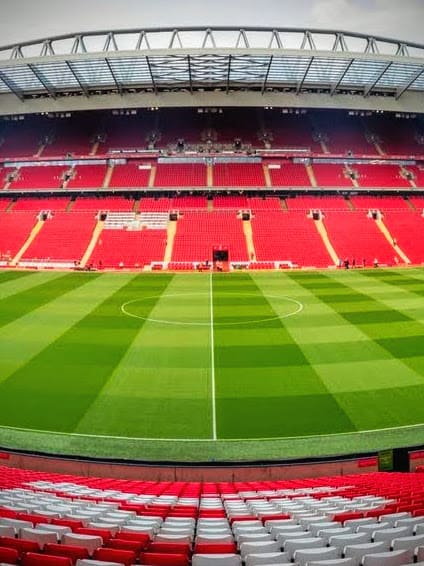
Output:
top-left (214, 273), bottom-right (355, 439)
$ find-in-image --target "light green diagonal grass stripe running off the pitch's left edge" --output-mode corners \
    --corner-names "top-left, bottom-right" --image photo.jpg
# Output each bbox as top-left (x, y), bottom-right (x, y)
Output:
top-left (0, 274), bottom-right (134, 388)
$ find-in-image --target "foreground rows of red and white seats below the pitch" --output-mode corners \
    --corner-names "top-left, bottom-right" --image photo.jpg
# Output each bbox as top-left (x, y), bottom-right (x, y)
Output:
top-left (0, 467), bottom-right (424, 566)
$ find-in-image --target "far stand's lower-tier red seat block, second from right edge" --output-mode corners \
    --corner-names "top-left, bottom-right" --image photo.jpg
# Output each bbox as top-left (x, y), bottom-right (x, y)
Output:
top-left (324, 210), bottom-right (396, 267)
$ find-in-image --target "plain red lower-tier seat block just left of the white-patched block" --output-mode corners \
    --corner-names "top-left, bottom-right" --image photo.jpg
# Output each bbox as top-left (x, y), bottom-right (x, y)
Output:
top-left (22, 212), bottom-right (96, 262)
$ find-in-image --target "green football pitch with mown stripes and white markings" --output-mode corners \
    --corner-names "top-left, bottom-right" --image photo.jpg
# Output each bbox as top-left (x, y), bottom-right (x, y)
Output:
top-left (0, 268), bottom-right (424, 462)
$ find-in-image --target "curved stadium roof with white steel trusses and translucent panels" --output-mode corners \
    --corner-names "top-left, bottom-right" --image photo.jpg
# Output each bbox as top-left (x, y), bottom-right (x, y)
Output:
top-left (0, 27), bottom-right (424, 114)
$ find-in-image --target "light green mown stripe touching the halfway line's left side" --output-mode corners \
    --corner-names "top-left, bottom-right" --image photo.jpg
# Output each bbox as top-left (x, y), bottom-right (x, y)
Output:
top-left (75, 273), bottom-right (212, 439)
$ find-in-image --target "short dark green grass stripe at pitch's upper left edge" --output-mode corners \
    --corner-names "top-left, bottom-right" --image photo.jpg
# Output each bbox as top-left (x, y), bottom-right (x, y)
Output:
top-left (0, 273), bottom-right (99, 327)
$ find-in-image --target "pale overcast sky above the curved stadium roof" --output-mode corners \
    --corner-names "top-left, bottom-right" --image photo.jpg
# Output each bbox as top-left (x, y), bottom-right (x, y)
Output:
top-left (0, 0), bottom-right (424, 45)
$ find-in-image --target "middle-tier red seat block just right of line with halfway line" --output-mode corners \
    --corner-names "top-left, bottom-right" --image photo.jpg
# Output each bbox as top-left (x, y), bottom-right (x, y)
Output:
top-left (213, 163), bottom-right (265, 187)
